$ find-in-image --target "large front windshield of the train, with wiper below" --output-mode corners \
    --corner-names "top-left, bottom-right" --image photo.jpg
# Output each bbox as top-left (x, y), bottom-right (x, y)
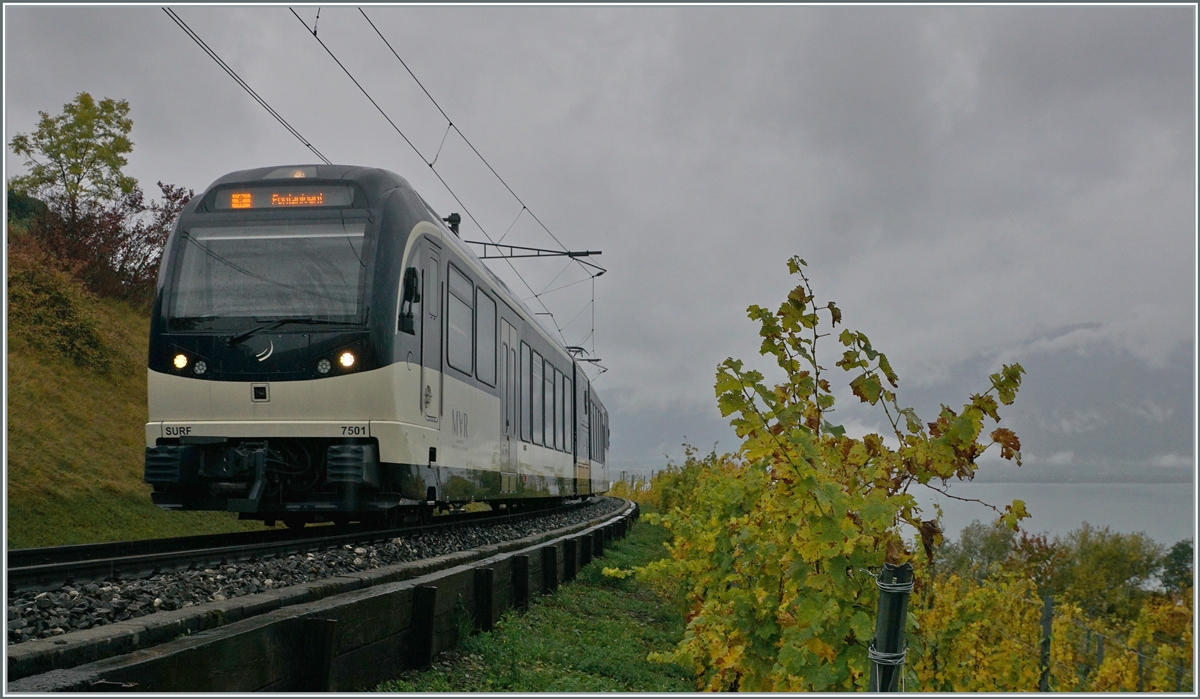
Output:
top-left (167, 221), bottom-right (366, 329)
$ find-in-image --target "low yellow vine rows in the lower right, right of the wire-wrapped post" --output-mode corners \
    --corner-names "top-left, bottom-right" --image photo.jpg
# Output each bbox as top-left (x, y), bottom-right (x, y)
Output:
top-left (910, 566), bottom-right (1193, 692)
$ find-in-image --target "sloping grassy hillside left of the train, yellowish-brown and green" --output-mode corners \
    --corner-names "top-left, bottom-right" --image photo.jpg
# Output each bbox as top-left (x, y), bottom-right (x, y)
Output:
top-left (5, 233), bottom-right (263, 549)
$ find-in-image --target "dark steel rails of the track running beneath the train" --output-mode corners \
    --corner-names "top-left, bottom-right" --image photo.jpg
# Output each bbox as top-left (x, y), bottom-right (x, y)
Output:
top-left (7, 502), bottom-right (582, 596)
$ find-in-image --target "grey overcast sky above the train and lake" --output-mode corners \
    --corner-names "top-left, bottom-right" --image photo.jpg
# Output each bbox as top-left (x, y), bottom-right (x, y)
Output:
top-left (5, 5), bottom-right (1196, 487)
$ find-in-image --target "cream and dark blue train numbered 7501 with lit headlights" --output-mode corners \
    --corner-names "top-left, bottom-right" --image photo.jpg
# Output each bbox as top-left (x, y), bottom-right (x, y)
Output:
top-left (144, 165), bottom-right (610, 527)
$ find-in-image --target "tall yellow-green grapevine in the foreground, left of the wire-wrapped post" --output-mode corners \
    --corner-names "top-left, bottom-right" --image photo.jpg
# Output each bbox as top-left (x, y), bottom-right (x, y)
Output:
top-left (624, 257), bottom-right (1028, 691)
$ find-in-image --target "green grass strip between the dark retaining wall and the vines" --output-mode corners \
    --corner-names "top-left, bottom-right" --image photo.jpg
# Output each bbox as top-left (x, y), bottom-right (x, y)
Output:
top-left (377, 522), bottom-right (695, 692)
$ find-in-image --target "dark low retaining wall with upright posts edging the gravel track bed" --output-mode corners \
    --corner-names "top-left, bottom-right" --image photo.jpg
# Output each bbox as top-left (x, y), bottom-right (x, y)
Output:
top-left (6, 501), bottom-right (637, 693)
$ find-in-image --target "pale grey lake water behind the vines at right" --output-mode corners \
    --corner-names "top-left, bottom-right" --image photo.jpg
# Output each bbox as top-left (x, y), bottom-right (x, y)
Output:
top-left (910, 482), bottom-right (1195, 546)
